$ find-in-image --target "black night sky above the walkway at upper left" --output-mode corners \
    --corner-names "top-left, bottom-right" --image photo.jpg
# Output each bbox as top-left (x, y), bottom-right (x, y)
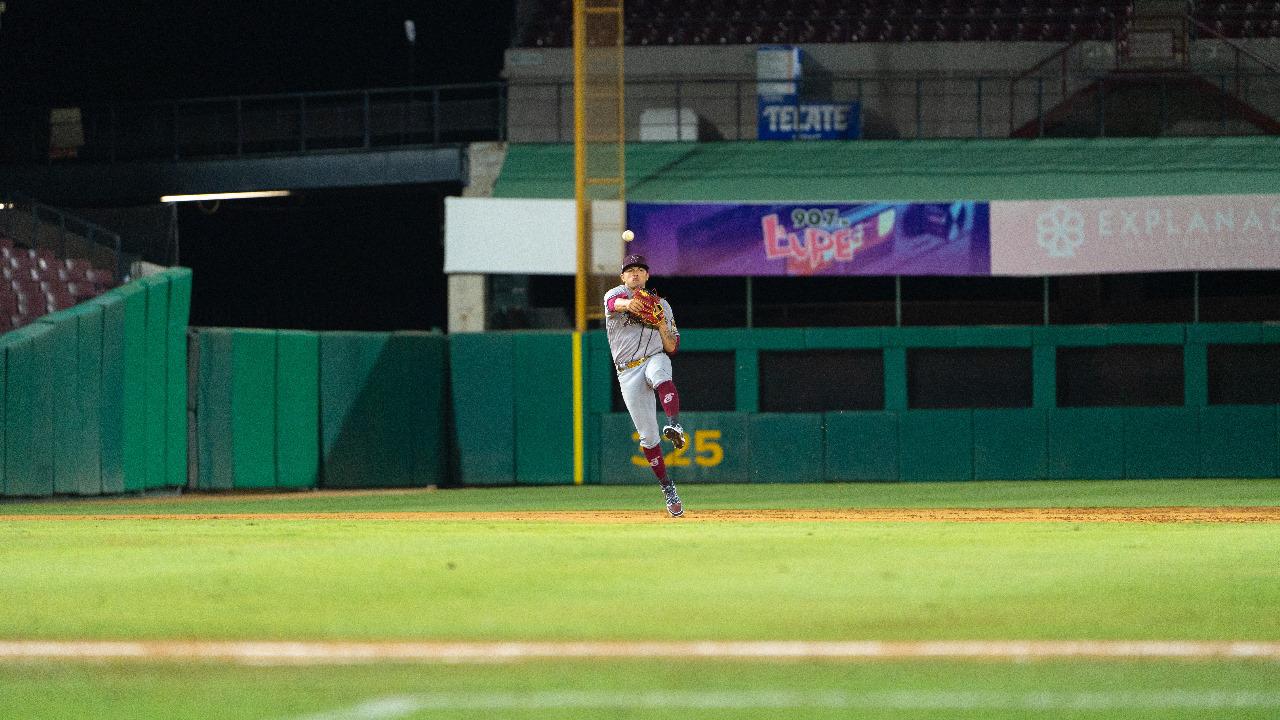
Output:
top-left (0, 0), bottom-right (515, 102)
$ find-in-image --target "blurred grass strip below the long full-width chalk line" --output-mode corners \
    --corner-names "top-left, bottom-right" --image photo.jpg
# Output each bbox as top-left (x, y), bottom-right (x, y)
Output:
top-left (0, 657), bottom-right (1280, 720)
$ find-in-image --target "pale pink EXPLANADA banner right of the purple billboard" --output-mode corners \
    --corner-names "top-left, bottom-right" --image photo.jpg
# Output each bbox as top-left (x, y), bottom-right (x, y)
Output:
top-left (991, 195), bottom-right (1280, 275)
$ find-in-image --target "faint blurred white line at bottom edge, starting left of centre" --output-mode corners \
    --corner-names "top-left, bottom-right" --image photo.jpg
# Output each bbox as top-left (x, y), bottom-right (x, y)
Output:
top-left (282, 689), bottom-right (1280, 720)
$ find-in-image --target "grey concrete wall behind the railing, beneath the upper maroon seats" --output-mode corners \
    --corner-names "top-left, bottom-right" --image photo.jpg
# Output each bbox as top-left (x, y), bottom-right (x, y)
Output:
top-left (503, 40), bottom-right (1280, 142)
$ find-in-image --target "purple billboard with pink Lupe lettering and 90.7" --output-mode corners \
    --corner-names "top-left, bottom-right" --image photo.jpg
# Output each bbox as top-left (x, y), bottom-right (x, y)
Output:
top-left (627, 201), bottom-right (991, 275)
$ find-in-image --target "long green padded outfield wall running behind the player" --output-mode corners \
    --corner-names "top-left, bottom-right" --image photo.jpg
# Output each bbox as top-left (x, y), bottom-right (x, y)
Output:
top-left (0, 295), bottom-right (1280, 497)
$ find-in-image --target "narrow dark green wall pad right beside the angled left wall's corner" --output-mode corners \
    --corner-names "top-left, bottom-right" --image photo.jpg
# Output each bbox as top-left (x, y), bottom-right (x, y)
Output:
top-left (196, 328), bottom-right (236, 489)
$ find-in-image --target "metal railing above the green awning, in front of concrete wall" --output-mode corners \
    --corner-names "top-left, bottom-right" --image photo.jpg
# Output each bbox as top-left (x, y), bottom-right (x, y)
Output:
top-left (508, 67), bottom-right (1280, 142)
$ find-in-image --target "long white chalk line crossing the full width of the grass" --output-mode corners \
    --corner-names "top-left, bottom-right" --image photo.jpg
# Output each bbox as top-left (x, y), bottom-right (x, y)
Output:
top-left (0, 641), bottom-right (1280, 665)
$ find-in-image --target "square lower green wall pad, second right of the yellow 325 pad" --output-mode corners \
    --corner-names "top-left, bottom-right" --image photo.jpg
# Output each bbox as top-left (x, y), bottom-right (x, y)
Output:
top-left (823, 411), bottom-right (899, 482)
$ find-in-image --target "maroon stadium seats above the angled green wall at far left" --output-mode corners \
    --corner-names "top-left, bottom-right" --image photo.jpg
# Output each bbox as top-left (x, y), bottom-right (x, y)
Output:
top-left (0, 234), bottom-right (116, 333)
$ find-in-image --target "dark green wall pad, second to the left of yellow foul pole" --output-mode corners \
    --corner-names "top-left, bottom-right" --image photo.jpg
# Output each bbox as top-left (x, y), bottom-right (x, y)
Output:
top-left (449, 333), bottom-right (516, 486)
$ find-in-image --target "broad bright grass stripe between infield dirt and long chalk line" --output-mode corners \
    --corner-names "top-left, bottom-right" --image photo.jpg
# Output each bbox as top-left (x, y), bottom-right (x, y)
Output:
top-left (0, 520), bottom-right (1280, 642)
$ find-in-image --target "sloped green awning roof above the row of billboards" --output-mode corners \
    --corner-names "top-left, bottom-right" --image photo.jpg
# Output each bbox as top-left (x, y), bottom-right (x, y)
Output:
top-left (494, 136), bottom-right (1280, 202)
